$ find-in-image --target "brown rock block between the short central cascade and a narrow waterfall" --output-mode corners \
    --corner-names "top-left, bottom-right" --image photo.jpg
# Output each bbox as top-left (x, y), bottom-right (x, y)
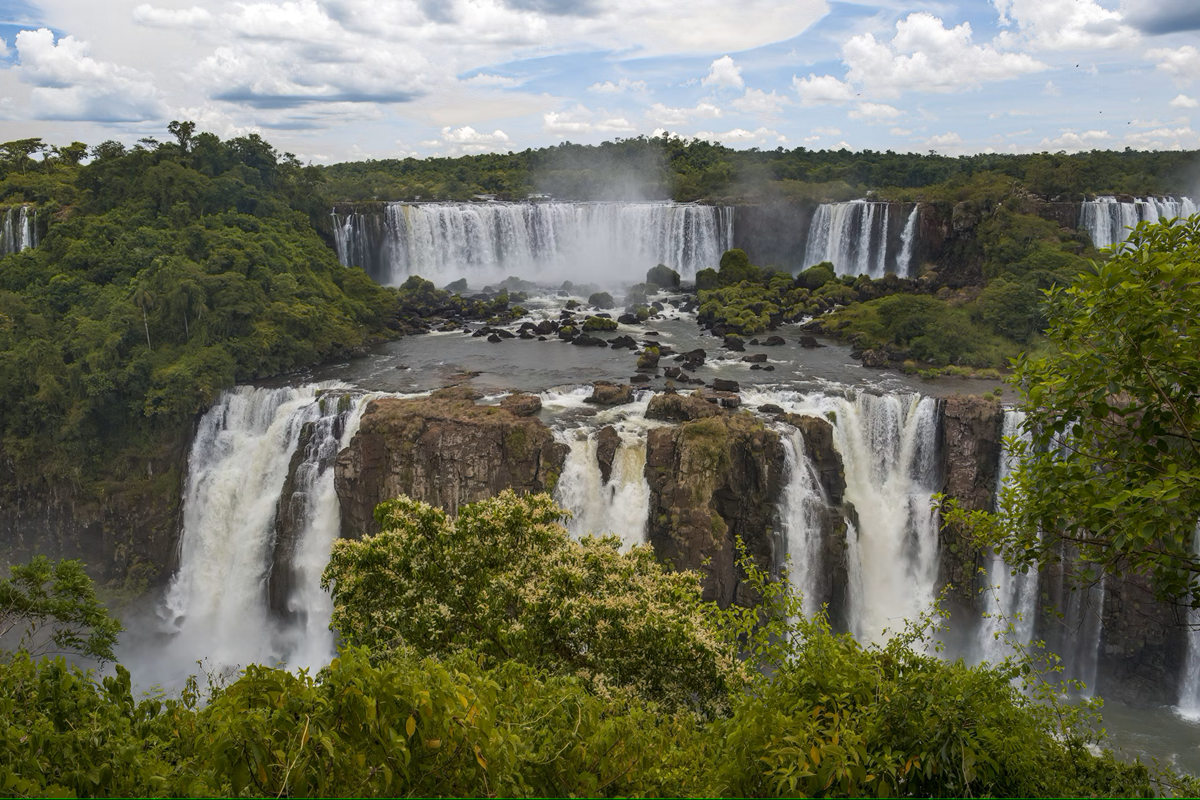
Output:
top-left (646, 412), bottom-right (785, 606)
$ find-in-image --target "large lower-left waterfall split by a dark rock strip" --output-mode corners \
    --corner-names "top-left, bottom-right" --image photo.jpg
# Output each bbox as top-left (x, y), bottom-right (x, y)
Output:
top-left (161, 385), bottom-right (366, 675)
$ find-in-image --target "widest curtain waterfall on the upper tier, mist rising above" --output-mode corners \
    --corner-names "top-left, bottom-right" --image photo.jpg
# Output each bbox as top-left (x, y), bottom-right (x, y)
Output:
top-left (334, 203), bottom-right (733, 285)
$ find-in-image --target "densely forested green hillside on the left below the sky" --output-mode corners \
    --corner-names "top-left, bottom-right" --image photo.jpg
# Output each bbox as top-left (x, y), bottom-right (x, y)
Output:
top-left (0, 124), bottom-right (505, 487)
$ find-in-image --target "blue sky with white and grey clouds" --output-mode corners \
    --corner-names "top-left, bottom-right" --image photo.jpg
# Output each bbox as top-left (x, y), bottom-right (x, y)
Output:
top-left (0, 0), bottom-right (1200, 163)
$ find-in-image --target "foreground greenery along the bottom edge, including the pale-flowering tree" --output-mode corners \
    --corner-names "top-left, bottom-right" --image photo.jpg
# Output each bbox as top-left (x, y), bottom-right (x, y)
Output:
top-left (0, 492), bottom-right (1200, 796)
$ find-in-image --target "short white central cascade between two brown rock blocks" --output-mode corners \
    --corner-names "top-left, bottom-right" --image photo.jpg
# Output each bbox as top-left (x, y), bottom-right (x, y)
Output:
top-left (554, 426), bottom-right (650, 548)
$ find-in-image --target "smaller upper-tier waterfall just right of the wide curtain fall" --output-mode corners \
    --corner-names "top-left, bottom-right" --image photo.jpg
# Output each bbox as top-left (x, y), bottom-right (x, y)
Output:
top-left (804, 200), bottom-right (918, 278)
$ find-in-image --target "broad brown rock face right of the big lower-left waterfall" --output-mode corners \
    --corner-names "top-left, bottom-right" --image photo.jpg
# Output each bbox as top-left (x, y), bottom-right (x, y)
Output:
top-left (335, 386), bottom-right (569, 537)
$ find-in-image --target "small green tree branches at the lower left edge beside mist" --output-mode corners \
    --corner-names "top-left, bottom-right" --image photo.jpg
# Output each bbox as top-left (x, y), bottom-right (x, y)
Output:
top-left (0, 555), bottom-right (121, 662)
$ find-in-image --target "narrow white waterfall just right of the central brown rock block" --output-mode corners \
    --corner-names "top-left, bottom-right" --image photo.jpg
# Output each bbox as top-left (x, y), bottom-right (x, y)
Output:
top-left (779, 428), bottom-right (830, 616)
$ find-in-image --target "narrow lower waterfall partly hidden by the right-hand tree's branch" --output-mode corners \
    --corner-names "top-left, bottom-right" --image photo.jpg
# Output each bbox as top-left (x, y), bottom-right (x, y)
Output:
top-left (979, 409), bottom-right (1038, 663)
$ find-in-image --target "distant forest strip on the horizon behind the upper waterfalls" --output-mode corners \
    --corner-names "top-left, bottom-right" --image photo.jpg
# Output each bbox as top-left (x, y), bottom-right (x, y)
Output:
top-left (320, 134), bottom-right (1200, 201)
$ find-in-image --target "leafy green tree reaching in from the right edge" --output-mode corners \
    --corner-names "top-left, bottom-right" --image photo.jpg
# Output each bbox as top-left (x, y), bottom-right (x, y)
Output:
top-left (950, 217), bottom-right (1200, 607)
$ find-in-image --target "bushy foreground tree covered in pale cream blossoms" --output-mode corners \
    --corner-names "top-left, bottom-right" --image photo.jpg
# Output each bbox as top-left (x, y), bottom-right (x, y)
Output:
top-left (323, 491), bottom-right (740, 714)
